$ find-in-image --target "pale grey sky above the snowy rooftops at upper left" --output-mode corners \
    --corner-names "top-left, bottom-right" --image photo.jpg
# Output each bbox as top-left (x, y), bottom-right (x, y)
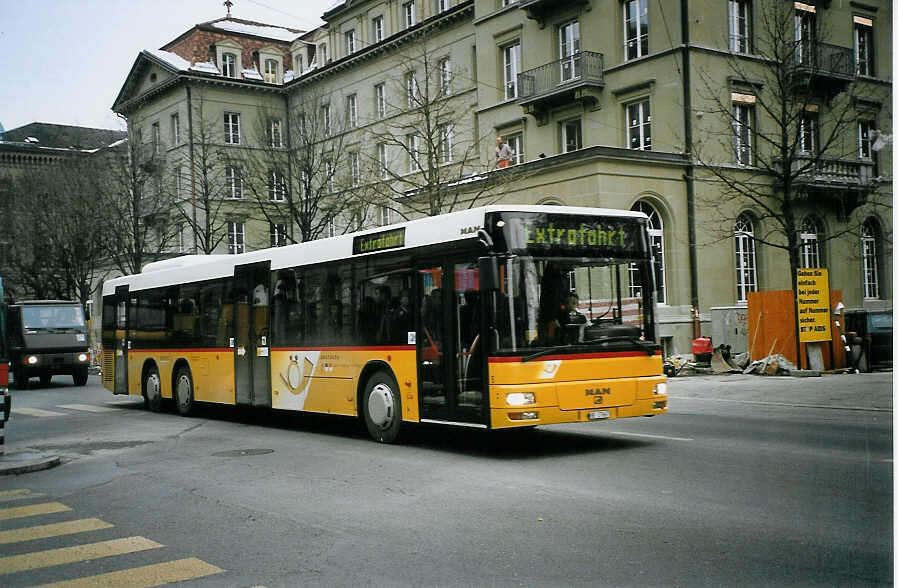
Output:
top-left (0, 0), bottom-right (334, 130)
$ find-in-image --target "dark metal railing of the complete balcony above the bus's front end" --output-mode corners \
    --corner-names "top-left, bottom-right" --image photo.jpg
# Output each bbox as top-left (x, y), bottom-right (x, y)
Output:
top-left (518, 51), bottom-right (605, 99)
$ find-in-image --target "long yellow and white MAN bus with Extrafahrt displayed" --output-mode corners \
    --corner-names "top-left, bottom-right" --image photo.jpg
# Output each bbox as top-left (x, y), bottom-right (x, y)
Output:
top-left (103, 206), bottom-right (667, 442)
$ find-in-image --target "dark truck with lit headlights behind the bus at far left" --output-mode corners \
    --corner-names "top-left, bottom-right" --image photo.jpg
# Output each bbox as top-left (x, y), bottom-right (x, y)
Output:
top-left (6, 300), bottom-right (90, 389)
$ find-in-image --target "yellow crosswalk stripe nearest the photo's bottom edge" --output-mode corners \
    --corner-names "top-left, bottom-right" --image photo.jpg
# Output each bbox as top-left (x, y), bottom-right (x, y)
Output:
top-left (40, 557), bottom-right (224, 588)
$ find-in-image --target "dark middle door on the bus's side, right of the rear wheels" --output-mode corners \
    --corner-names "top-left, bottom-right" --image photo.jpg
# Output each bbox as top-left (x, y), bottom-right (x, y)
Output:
top-left (234, 261), bottom-right (271, 407)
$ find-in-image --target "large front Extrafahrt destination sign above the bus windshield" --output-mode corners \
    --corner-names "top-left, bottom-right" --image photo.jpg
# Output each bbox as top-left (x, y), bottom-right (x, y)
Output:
top-left (494, 214), bottom-right (646, 257)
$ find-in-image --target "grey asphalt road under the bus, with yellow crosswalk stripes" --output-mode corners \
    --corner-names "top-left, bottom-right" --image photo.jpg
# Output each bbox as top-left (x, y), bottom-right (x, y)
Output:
top-left (0, 374), bottom-right (893, 588)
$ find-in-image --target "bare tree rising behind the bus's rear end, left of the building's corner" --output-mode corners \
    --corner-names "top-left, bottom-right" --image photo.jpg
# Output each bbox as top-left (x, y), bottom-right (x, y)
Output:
top-left (93, 124), bottom-right (175, 274)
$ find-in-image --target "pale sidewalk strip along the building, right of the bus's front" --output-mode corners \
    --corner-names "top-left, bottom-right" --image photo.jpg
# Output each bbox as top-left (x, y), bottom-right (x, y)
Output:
top-left (667, 372), bottom-right (893, 411)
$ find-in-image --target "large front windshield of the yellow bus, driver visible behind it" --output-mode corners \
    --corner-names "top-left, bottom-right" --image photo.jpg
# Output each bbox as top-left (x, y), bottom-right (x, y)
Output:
top-left (493, 255), bottom-right (654, 356)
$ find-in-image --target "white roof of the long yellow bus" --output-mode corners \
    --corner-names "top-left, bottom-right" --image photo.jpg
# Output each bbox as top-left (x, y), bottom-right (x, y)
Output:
top-left (103, 205), bottom-right (646, 296)
